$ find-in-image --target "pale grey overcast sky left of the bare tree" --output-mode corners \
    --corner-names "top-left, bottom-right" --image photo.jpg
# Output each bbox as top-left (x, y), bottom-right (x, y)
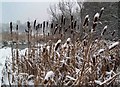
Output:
top-left (2, 2), bottom-right (55, 23)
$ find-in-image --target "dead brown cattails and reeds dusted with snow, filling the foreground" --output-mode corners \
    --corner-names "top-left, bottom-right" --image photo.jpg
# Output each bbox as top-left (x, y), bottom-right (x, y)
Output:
top-left (1, 8), bottom-right (120, 87)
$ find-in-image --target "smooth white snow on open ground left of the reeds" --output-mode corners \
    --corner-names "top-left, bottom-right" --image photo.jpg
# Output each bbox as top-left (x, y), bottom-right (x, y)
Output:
top-left (0, 48), bottom-right (11, 86)
